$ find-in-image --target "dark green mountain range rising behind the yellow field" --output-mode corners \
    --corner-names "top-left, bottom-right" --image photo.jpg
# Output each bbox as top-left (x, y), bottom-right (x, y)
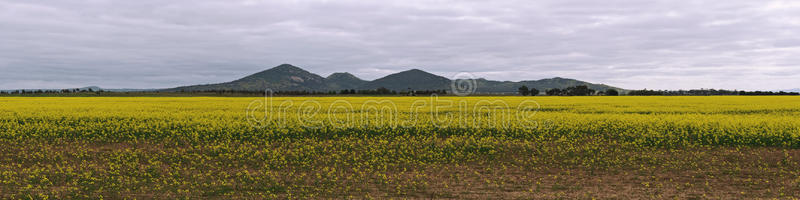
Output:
top-left (162, 64), bottom-right (622, 93)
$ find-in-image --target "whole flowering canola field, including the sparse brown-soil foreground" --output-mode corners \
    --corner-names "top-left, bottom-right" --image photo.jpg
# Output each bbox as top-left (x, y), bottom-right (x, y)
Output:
top-left (0, 96), bottom-right (800, 199)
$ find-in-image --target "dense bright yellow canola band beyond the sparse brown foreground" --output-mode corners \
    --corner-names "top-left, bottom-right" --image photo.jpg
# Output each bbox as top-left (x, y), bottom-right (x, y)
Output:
top-left (0, 96), bottom-right (800, 148)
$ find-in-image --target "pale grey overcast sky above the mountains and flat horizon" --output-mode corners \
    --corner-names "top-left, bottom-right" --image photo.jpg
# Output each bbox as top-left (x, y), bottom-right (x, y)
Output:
top-left (0, 0), bottom-right (800, 90)
